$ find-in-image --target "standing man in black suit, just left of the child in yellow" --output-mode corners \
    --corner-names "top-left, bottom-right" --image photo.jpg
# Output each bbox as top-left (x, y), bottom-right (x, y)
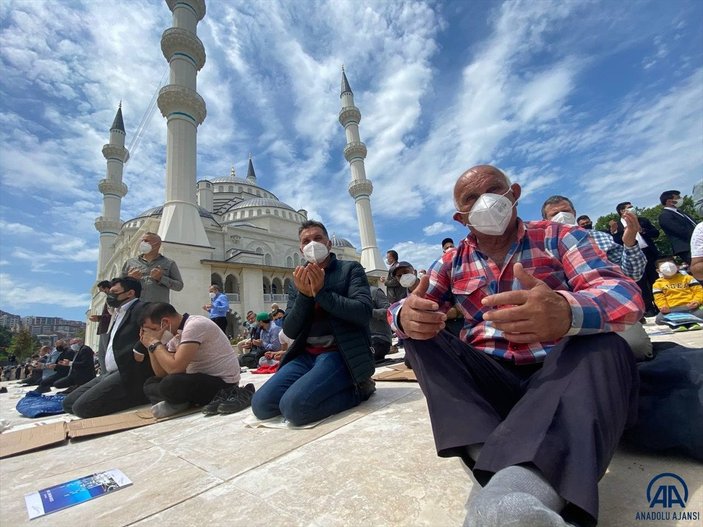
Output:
top-left (610, 201), bottom-right (659, 317)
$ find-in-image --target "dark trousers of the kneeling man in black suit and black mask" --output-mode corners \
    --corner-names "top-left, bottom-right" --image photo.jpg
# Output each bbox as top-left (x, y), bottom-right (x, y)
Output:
top-left (63, 371), bottom-right (148, 418)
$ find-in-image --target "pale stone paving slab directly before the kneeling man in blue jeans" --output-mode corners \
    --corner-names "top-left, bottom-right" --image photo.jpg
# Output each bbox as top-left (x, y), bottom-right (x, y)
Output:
top-left (132, 383), bottom-right (424, 480)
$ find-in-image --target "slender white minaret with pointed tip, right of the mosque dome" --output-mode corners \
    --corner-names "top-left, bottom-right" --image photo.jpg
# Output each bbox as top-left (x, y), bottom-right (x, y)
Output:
top-left (339, 67), bottom-right (386, 274)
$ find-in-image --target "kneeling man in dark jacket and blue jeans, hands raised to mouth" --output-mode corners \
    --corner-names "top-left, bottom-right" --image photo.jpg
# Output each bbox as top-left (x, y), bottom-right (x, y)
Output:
top-left (251, 221), bottom-right (375, 425)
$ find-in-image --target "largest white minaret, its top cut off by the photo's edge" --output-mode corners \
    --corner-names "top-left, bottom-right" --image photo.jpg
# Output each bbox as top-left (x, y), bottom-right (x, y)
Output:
top-left (158, 0), bottom-right (210, 247)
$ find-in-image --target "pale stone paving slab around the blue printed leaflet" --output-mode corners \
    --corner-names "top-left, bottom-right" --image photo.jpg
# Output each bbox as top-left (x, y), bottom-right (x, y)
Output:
top-left (0, 446), bottom-right (221, 527)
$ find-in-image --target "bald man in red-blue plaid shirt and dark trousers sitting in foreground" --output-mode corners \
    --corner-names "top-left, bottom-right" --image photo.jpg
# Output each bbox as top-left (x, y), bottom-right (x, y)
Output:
top-left (389, 165), bottom-right (644, 527)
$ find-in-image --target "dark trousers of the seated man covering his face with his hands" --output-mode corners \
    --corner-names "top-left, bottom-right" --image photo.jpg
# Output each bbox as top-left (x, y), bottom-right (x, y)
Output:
top-left (144, 373), bottom-right (231, 405)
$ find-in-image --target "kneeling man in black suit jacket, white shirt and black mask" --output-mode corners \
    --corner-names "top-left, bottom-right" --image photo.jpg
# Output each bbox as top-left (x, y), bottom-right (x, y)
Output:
top-left (63, 277), bottom-right (154, 418)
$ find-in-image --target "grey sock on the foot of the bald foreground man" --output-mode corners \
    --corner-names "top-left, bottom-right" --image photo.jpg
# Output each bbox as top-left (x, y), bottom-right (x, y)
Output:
top-left (464, 466), bottom-right (566, 527)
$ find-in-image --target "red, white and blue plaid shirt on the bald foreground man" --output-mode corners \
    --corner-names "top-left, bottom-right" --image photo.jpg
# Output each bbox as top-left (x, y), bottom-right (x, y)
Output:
top-left (388, 219), bottom-right (644, 364)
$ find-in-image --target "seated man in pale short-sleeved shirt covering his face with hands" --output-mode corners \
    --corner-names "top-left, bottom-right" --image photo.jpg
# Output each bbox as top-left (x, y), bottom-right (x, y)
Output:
top-left (139, 302), bottom-right (248, 417)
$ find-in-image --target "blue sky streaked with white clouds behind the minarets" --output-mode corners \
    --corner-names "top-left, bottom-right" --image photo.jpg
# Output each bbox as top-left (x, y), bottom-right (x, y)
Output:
top-left (0, 0), bottom-right (703, 320)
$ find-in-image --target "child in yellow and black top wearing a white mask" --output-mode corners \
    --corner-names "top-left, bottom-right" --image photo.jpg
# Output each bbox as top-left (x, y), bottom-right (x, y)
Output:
top-left (652, 258), bottom-right (703, 331)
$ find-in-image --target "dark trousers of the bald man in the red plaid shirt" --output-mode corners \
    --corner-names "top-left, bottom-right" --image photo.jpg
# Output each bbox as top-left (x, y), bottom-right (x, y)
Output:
top-left (405, 331), bottom-right (638, 525)
